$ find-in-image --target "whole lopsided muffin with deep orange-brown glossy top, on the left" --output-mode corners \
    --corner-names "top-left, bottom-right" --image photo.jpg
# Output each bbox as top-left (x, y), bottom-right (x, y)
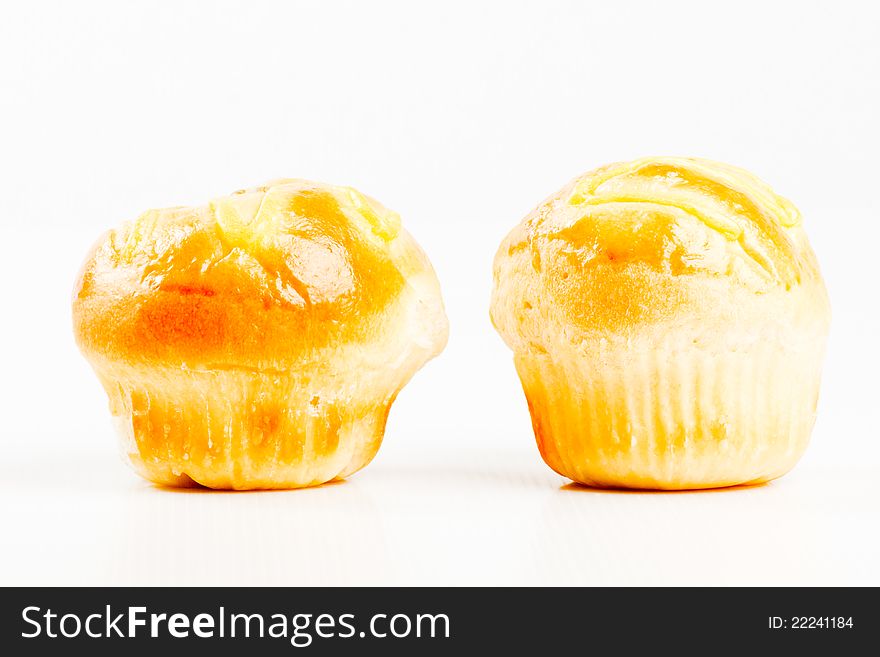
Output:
top-left (73, 180), bottom-right (448, 489)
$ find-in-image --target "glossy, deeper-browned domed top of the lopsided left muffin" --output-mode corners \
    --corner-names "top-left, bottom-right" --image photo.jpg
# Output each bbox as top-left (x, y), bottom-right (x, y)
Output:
top-left (73, 180), bottom-right (422, 368)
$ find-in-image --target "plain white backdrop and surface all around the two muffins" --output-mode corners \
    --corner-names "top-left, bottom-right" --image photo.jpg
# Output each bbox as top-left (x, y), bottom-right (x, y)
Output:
top-left (0, 0), bottom-right (880, 585)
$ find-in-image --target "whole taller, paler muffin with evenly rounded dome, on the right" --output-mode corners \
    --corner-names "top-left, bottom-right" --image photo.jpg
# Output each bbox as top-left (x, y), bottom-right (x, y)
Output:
top-left (491, 158), bottom-right (830, 489)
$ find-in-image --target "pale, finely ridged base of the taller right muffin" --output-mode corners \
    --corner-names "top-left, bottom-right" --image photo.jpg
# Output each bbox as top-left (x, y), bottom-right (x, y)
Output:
top-left (516, 335), bottom-right (824, 490)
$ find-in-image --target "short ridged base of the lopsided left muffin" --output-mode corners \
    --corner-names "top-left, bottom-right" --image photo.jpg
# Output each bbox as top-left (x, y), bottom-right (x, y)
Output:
top-left (99, 366), bottom-right (396, 490)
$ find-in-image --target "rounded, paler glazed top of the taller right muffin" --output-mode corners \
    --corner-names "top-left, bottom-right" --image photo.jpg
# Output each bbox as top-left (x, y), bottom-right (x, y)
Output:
top-left (492, 157), bottom-right (828, 349)
